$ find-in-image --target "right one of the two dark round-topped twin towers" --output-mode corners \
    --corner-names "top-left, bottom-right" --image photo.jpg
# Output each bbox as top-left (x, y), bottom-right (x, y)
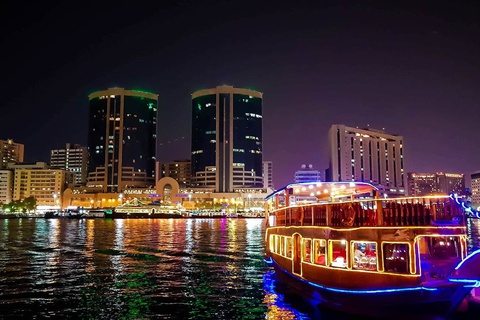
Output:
top-left (192, 86), bottom-right (263, 192)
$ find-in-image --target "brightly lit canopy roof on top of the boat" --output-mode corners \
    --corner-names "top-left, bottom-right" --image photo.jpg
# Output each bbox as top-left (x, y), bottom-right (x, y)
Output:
top-left (265, 181), bottom-right (378, 200)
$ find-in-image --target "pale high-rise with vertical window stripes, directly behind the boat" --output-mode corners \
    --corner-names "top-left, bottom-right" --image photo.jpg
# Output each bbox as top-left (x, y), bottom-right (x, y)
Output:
top-left (327, 124), bottom-right (405, 195)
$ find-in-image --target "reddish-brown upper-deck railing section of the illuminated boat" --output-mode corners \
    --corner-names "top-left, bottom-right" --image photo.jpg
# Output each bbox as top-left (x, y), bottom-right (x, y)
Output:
top-left (270, 197), bottom-right (465, 227)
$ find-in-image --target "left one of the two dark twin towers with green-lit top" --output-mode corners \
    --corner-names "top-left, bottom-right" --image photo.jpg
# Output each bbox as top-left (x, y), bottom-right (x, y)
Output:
top-left (87, 88), bottom-right (158, 193)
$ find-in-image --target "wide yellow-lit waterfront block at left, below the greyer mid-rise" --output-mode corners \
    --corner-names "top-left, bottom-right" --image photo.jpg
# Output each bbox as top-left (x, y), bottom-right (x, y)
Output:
top-left (9, 162), bottom-right (68, 209)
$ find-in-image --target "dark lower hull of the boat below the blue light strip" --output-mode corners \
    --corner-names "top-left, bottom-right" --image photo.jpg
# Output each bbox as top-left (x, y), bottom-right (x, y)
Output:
top-left (269, 259), bottom-right (471, 319)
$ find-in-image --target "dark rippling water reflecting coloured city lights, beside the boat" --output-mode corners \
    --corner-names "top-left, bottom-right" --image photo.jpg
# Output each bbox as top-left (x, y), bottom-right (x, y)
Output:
top-left (0, 218), bottom-right (478, 320)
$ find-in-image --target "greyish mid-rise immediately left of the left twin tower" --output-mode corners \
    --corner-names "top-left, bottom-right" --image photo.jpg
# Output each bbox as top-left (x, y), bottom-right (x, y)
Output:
top-left (50, 143), bottom-right (88, 185)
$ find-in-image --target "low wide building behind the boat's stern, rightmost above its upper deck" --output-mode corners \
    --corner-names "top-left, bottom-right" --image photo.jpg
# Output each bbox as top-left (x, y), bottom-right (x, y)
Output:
top-left (407, 172), bottom-right (465, 196)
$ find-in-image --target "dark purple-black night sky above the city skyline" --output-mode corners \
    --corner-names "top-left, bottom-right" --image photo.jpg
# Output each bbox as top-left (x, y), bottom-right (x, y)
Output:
top-left (0, 0), bottom-right (480, 187)
